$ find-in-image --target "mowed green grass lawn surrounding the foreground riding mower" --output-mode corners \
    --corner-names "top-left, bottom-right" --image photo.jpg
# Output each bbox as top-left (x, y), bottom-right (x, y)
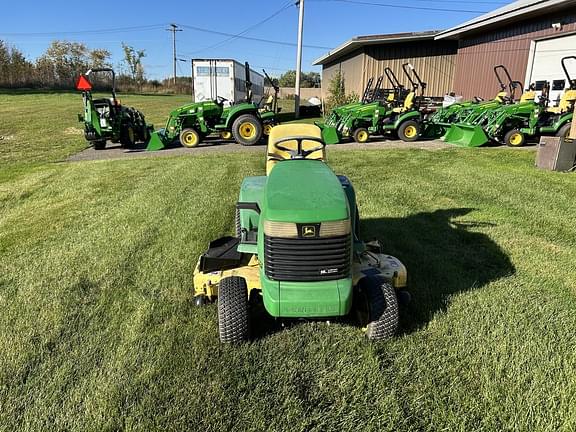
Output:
top-left (0, 91), bottom-right (576, 431)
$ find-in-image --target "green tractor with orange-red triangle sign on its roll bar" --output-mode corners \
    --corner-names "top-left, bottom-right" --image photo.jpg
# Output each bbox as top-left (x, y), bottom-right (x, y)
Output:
top-left (76, 68), bottom-right (154, 150)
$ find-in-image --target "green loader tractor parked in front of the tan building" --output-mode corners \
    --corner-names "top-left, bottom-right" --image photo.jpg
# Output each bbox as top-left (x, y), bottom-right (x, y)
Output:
top-left (318, 63), bottom-right (426, 144)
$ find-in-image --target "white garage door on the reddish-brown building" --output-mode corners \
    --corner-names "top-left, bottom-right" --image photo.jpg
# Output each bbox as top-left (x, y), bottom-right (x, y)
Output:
top-left (526, 34), bottom-right (576, 104)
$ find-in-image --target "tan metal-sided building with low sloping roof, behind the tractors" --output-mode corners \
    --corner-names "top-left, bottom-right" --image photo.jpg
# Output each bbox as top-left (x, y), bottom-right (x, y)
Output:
top-left (314, 31), bottom-right (458, 97)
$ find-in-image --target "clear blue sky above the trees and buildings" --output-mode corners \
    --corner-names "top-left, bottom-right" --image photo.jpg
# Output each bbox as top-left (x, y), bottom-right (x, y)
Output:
top-left (0, 0), bottom-right (510, 78)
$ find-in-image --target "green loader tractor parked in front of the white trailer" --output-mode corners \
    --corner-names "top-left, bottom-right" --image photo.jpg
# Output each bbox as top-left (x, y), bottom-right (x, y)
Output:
top-left (147, 63), bottom-right (279, 150)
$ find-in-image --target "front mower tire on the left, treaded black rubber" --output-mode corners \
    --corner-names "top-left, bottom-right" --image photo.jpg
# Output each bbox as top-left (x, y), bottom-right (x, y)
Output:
top-left (218, 276), bottom-right (250, 343)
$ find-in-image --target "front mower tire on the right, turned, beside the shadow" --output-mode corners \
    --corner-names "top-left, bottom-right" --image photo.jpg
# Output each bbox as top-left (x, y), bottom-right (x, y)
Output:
top-left (354, 276), bottom-right (399, 340)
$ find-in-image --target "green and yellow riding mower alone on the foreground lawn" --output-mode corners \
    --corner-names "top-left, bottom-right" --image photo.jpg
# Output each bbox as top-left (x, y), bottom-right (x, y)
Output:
top-left (194, 124), bottom-right (406, 342)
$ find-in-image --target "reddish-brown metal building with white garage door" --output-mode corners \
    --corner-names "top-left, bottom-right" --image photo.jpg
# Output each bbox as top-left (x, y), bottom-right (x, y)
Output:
top-left (435, 0), bottom-right (576, 99)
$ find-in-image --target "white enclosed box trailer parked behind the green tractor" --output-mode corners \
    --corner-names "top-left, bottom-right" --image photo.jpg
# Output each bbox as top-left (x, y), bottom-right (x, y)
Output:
top-left (192, 59), bottom-right (264, 104)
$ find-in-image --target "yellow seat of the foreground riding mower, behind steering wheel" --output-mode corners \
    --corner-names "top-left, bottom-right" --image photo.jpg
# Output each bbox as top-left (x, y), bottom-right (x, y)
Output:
top-left (266, 123), bottom-right (326, 175)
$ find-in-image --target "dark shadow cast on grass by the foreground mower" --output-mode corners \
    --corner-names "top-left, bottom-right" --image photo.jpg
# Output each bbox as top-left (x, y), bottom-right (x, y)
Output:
top-left (360, 208), bottom-right (516, 333)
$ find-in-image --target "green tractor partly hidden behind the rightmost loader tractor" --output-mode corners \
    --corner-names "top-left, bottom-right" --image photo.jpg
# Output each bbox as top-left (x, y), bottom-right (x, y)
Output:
top-left (422, 65), bottom-right (521, 138)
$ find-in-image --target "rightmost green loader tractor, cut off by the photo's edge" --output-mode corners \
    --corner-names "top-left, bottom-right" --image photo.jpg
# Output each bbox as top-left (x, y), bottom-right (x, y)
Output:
top-left (445, 56), bottom-right (576, 147)
